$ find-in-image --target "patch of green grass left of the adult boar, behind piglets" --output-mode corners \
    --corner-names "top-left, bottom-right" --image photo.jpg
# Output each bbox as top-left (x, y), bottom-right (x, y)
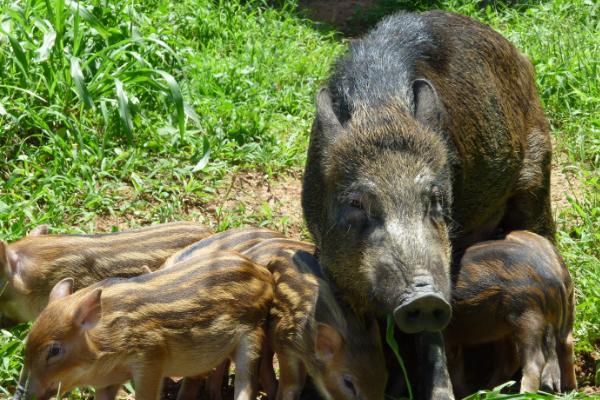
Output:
top-left (0, 0), bottom-right (339, 239)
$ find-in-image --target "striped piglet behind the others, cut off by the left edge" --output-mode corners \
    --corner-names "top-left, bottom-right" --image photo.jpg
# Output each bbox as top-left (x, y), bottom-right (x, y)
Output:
top-left (0, 222), bottom-right (212, 328)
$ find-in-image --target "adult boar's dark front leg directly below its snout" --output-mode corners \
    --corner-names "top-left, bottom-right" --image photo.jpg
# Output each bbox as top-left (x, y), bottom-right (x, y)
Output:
top-left (417, 332), bottom-right (454, 400)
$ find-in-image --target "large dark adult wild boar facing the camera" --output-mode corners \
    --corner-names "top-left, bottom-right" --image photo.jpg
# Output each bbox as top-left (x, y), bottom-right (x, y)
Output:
top-left (302, 11), bottom-right (555, 398)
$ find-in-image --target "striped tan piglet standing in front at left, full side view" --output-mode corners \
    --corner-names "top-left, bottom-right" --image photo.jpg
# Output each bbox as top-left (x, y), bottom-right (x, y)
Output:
top-left (25, 252), bottom-right (273, 400)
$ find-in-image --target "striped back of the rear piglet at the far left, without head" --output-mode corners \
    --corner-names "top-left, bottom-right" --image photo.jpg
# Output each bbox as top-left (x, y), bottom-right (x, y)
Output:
top-left (10, 222), bottom-right (212, 293)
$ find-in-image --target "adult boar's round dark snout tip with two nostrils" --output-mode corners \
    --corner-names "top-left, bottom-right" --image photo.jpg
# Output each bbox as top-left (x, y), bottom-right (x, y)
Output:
top-left (394, 293), bottom-right (452, 333)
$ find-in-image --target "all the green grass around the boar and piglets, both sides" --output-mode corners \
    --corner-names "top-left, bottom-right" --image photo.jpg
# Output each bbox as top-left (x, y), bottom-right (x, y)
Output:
top-left (0, 0), bottom-right (600, 399)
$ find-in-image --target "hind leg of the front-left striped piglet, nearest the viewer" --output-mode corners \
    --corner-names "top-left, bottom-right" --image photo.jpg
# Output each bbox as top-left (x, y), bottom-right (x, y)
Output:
top-left (233, 328), bottom-right (264, 400)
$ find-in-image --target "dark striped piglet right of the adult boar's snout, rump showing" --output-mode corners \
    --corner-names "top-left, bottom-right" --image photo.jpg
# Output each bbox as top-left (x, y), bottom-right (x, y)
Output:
top-left (445, 231), bottom-right (577, 395)
